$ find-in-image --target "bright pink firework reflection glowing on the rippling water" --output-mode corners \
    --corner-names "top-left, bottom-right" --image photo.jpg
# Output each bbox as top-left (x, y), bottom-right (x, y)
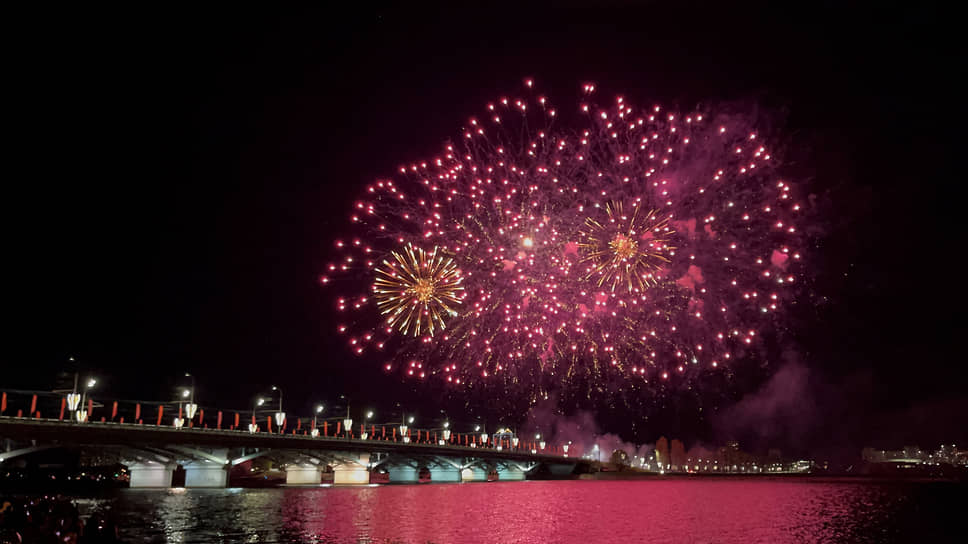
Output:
top-left (260, 479), bottom-right (908, 544)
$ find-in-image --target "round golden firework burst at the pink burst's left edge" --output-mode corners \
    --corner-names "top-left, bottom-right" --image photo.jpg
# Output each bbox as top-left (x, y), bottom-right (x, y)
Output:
top-left (373, 244), bottom-right (464, 336)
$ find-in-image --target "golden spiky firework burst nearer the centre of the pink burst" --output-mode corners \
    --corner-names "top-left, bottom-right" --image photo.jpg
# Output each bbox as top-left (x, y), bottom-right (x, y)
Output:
top-left (578, 202), bottom-right (675, 291)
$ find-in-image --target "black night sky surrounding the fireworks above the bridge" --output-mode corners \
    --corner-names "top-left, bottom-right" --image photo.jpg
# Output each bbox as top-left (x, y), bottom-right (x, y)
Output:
top-left (0, 2), bottom-right (968, 455)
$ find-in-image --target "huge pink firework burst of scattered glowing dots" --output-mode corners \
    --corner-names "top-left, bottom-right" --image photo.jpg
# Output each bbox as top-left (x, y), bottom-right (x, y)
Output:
top-left (322, 82), bottom-right (804, 396)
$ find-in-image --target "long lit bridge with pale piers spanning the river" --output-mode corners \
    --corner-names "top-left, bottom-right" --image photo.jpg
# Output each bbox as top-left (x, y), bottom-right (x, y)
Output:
top-left (0, 393), bottom-right (587, 488)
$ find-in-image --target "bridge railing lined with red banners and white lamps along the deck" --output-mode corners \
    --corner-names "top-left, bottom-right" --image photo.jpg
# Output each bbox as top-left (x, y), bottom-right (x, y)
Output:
top-left (0, 390), bottom-right (567, 457)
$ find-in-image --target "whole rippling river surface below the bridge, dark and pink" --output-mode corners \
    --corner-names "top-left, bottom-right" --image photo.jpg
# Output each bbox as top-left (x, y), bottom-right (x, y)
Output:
top-left (68, 478), bottom-right (968, 544)
